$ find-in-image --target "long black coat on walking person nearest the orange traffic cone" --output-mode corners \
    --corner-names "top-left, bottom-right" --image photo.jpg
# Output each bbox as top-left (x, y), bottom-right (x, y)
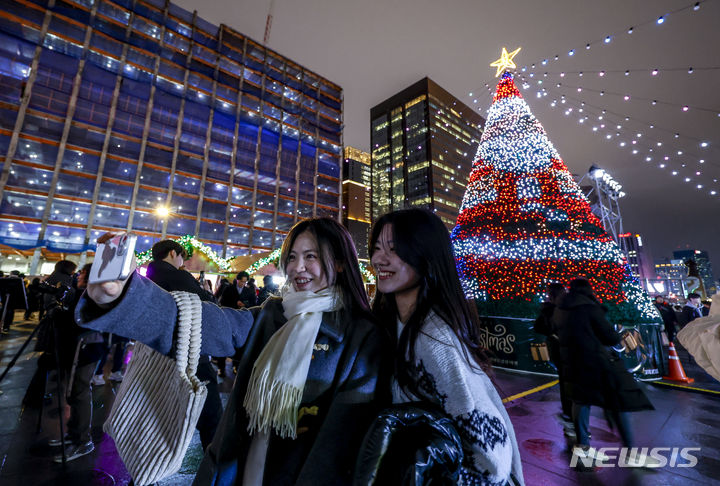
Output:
top-left (553, 290), bottom-right (653, 412)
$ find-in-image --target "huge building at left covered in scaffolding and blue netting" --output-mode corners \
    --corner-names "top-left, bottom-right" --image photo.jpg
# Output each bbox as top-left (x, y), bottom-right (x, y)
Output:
top-left (0, 0), bottom-right (343, 270)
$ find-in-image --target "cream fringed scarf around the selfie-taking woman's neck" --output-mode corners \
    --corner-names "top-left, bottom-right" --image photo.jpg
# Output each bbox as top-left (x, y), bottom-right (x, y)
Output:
top-left (243, 287), bottom-right (342, 439)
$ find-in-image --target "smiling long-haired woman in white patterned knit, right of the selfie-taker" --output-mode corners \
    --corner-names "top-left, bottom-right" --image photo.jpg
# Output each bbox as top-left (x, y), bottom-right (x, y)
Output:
top-left (369, 209), bottom-right (524, 485)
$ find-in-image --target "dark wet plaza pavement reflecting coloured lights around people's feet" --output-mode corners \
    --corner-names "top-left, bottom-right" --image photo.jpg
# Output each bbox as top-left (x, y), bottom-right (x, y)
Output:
top-left (0, 312), bottom-right (720, 486)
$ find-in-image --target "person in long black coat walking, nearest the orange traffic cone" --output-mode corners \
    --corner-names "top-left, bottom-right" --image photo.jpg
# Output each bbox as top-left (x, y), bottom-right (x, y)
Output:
top-left (553, 278), bottom-right (654, 466)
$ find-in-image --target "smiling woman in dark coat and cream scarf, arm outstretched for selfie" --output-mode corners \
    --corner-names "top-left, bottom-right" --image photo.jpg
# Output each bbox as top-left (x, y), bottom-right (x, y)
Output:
top-left (77, 218), bottom-right (389, 486)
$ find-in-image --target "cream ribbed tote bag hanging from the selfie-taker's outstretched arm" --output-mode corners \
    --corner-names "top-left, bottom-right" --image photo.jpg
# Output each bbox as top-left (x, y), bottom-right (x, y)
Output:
top-left (103, 292), bottom-right (207, 486)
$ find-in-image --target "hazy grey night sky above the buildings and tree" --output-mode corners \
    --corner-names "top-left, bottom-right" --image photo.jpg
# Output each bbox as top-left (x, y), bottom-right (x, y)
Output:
top-left (175, 0), bottom-right (720, 277)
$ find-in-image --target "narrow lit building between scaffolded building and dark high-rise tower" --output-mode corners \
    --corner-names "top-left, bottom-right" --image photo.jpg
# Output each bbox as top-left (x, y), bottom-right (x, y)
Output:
top-left (342, 147), bottom-right (372, 260)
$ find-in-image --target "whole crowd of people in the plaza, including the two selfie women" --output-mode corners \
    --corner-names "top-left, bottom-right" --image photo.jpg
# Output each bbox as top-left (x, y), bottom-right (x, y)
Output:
top-left (0, 209), bottom-right (716, 485)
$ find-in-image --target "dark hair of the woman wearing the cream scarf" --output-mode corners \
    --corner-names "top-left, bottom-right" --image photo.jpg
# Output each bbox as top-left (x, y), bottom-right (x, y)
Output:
top-left (280, 218), bottom-right (375, 321)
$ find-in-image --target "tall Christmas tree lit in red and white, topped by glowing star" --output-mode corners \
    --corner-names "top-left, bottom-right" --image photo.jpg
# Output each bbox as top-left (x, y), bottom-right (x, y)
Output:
top-left (452, 62), bottom-right (661, 325)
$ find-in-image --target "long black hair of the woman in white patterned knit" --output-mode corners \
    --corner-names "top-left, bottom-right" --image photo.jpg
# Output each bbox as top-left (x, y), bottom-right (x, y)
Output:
top-left (369, 208), bottom-right (491, 396)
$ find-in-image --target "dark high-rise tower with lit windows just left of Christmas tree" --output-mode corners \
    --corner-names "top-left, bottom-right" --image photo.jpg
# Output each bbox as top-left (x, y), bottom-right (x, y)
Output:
top-left (370, 78), bottom-right (485, 228)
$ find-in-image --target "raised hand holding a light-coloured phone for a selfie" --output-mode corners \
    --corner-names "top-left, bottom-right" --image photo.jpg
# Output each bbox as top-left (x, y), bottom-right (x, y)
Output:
top-left (87, 233), bottom-right (137, 306)
